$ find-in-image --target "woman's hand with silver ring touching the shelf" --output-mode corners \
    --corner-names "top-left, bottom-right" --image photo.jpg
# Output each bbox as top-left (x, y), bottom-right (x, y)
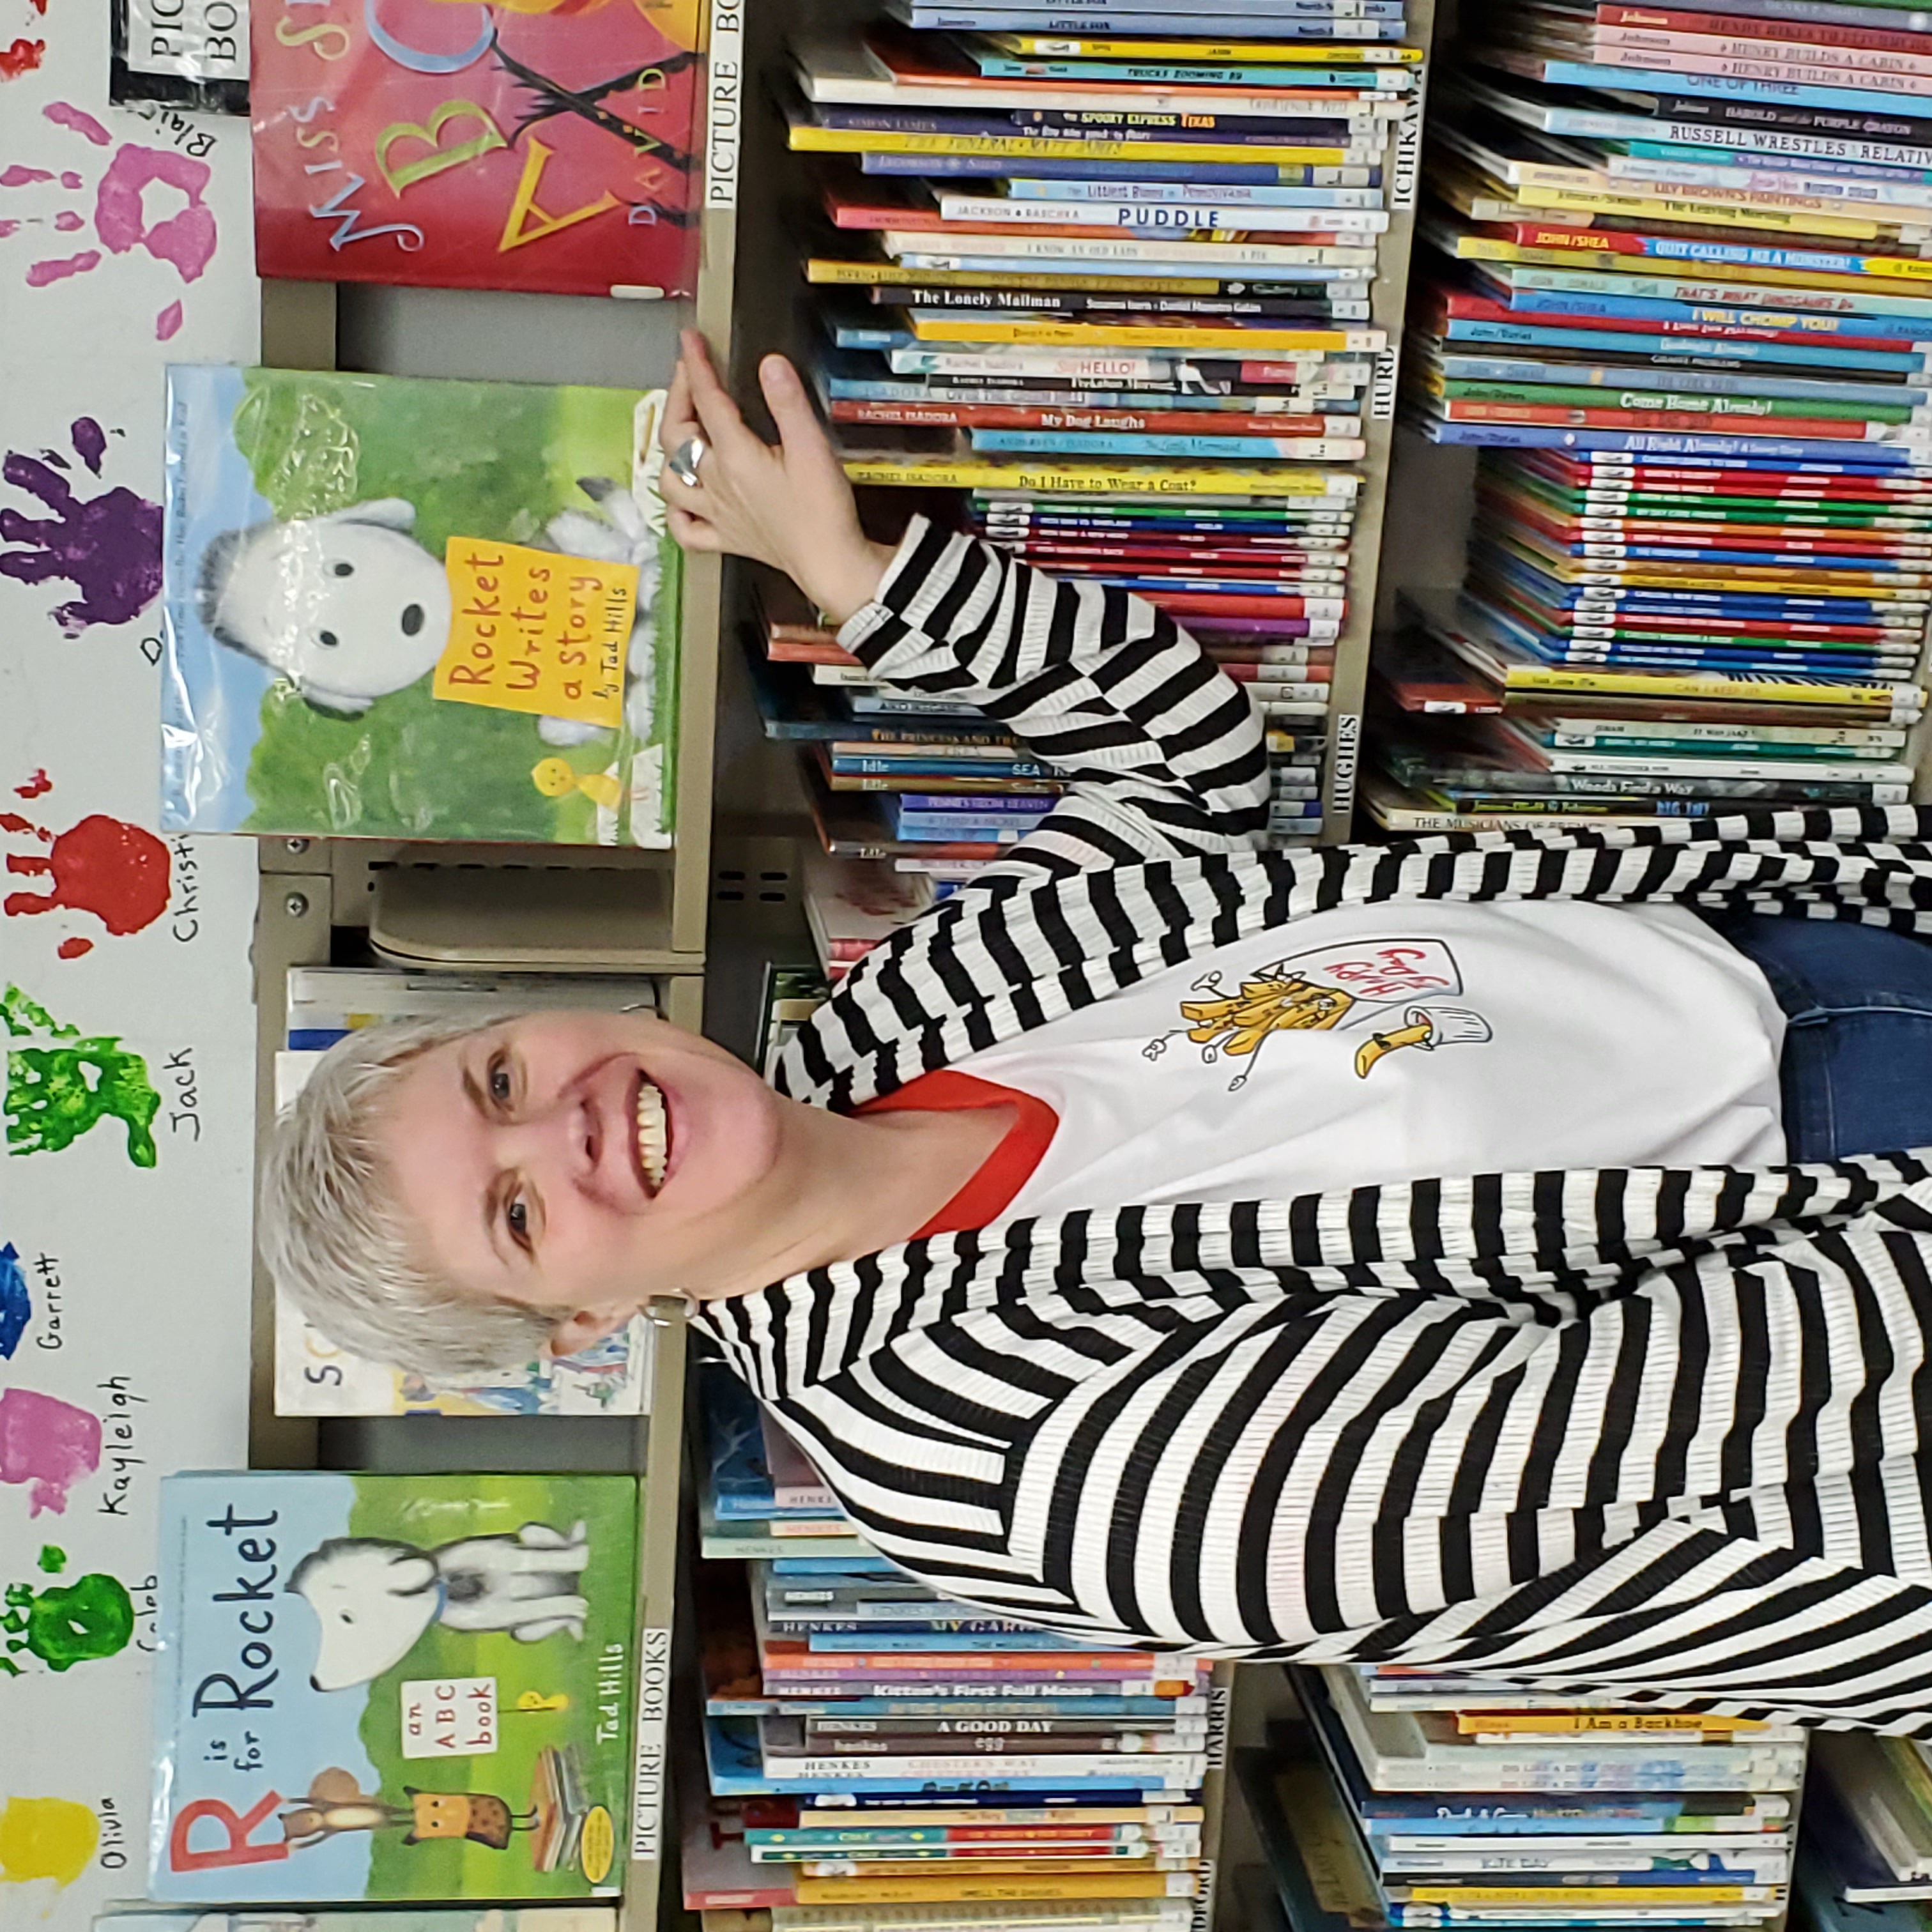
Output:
top-left (659, 328), bottom-right (894, 624)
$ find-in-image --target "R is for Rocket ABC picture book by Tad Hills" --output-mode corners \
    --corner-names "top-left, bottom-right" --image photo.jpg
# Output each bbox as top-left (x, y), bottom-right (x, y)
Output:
top-left (149, 1470), bottom-right (638, 1905)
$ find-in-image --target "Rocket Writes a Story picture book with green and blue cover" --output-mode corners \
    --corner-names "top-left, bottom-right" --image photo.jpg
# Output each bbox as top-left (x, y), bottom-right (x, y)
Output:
top-left (162, 367), bottom-right (678, 847)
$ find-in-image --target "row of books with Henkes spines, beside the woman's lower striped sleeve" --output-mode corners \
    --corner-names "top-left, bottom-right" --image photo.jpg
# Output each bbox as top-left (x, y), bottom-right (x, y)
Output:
top-left (682, 1364), bottom-right (1215, 1932)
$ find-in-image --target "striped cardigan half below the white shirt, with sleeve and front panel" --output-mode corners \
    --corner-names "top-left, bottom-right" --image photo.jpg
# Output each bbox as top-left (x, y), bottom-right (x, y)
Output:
top-left (702, 1155), bottom-right (1932, 1729)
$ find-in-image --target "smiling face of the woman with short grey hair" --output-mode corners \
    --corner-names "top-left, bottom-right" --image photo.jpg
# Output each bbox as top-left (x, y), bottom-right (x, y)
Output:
top-left (369, 1013), bottom-right (796, 1353)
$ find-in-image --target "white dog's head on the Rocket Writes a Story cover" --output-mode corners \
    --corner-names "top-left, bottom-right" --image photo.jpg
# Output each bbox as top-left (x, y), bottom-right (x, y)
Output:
top-left (215, 516), bottom-right (450, 711)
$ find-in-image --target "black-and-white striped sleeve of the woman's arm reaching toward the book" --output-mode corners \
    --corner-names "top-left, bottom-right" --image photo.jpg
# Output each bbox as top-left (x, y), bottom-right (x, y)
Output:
top-left (838, 518), bottom-right (1268, 873)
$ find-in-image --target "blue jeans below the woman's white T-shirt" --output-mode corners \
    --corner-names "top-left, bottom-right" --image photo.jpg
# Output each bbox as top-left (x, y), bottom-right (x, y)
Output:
top-left (1706, 912), bottom-right (1932, 1161)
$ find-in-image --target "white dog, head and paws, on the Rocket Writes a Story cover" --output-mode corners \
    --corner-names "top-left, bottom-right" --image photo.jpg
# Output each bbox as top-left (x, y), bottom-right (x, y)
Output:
top-left (195, 477), bottom-right (659, 746)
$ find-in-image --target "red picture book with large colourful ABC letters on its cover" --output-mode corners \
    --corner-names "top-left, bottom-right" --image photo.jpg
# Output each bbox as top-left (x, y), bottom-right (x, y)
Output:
top-left (249, 0), bottom-right (705, 296)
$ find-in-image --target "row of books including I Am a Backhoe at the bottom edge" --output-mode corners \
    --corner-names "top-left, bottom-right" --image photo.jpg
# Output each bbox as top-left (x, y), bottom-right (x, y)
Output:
top-left (1234, 1666), bottom-right (1804, 1932)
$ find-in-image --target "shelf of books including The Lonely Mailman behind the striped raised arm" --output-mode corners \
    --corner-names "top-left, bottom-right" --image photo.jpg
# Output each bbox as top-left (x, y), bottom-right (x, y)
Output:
top-left (788, 0), bottom-right (1422, 868)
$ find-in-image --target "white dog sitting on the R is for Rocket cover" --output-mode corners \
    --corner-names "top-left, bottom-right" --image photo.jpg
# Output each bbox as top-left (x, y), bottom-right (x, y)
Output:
top-left (288, 1522), bottom-right (591, 1690)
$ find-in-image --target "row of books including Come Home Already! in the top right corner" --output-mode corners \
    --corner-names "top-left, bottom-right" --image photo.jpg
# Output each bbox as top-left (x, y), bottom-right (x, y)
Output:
top-left (1372, 0), bottom-right (1932, 829)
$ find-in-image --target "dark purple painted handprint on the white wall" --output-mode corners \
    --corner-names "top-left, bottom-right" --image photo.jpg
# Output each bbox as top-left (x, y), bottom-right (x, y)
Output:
top-left (0, 415), bottom-right (160, 638)
